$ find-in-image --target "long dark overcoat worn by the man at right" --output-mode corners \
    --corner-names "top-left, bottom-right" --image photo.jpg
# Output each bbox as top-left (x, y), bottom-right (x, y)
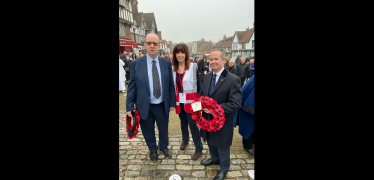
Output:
top-left (199, 69), bottom-right (242, 148)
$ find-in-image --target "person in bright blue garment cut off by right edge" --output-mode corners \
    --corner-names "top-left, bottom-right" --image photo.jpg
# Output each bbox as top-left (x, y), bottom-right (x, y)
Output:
top-left (234, 75), bottom-right (255, 156)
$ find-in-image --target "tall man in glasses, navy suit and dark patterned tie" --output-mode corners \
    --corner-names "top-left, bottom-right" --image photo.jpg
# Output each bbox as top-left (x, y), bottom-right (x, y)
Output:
top-left (126, 33), bottom-right (176, 161)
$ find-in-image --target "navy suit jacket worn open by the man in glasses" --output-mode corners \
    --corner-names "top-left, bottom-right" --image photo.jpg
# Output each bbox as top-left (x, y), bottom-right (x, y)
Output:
top-left (126, 56), bottom-right (176, 119)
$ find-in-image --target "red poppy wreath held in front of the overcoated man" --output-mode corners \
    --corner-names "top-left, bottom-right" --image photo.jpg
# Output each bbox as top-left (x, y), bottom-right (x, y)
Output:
top-left (192, 96), bottom-right (225, 132)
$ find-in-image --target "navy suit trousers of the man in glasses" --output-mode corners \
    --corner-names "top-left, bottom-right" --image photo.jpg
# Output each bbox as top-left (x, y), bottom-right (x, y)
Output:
top-left (140, 103), bottom-right (169, 152)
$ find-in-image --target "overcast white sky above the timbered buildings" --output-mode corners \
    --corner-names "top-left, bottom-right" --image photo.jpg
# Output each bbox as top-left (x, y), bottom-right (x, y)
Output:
top-left (138, 0), bottom-right (254, 43)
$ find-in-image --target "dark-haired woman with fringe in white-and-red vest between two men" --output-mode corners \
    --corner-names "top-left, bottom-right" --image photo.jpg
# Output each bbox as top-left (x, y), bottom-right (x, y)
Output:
top-left (172, 44), bottom-right (203, 160)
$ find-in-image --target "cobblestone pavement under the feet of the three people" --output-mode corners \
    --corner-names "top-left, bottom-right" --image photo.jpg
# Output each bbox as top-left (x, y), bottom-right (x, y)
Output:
top-left (119, 111), bottom-right (254, 180)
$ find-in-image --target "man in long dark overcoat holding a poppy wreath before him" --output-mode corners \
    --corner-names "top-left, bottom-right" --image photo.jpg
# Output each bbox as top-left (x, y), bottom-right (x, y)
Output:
top-left (199, 50), bottom-right (242, 180)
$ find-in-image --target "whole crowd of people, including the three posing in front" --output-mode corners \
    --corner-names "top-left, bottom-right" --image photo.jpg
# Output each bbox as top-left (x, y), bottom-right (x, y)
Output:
top-left (120, 33), bottom-right (254, 180)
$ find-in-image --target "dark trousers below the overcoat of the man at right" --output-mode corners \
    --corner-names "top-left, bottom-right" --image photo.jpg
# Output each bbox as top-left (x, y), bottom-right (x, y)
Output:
top-left (206, 132), bottom-right (230, 173)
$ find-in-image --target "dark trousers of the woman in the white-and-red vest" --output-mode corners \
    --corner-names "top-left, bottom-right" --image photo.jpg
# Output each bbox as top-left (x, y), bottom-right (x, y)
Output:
top-left (179, 103), bottom-right (203, 153)
